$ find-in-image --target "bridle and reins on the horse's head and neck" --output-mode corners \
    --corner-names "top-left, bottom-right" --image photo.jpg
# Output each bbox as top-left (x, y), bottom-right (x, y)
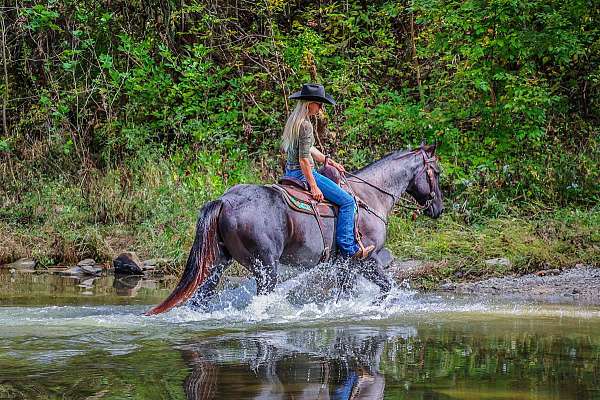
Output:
top-left (342, 147), bottom-right (440, 224)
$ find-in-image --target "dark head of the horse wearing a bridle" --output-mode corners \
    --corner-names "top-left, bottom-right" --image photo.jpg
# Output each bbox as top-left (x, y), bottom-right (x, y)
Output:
top-left (406, 145), bottom-right (444, 218)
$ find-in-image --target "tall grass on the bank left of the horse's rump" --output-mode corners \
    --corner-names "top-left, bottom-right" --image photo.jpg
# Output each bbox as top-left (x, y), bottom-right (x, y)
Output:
top-left (0, 151), bottom-right (257, 265)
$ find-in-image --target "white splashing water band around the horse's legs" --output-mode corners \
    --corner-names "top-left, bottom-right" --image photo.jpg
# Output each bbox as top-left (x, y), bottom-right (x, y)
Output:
top-left (0, 266), bottom-right (600, 335)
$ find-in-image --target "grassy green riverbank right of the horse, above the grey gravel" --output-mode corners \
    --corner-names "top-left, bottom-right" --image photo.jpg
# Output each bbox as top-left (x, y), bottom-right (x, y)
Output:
top-left (388, 209), bottom-right (600, 290)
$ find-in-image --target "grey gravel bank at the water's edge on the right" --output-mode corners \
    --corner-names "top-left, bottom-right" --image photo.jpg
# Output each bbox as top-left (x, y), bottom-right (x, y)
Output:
top-left (440, 266), bottom-right (600, 305)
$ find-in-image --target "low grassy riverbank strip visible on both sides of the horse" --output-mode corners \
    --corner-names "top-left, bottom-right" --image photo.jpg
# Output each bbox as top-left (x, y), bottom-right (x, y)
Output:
top-left (0, 205), bottom-right (600, 290)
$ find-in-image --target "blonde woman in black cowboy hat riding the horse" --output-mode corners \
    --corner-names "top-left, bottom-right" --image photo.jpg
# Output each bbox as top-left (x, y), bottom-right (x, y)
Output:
top-left (281, 83), bottom-right (375, 260)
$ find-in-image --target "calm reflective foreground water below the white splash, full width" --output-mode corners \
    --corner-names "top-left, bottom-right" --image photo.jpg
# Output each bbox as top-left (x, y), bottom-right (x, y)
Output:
top-left (0, 314), bottom-right (600, 400)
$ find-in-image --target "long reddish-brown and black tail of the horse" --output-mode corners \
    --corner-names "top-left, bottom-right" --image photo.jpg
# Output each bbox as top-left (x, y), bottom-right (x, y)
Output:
top-left (146, 200), bottom-right (223, 315)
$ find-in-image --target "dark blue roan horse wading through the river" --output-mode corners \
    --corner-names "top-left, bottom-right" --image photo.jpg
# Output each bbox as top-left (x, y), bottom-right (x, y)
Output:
top-left (147, 146), bottom-right (444, 315)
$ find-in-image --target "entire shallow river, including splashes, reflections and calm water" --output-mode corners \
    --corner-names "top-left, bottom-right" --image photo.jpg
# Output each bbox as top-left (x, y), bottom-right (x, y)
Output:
top-left (0, 271), bottom-right (600, 399)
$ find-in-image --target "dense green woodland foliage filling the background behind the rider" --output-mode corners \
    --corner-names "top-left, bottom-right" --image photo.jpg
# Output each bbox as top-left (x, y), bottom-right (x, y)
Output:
top-left (0, 0), bottom-right (600, 266)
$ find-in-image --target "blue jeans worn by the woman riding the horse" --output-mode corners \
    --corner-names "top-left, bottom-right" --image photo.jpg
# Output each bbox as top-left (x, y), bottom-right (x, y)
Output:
top-left (285, 169), bottom-right (359, 256)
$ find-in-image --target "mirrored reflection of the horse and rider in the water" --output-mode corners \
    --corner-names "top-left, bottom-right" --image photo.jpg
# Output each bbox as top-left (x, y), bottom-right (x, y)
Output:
top-left (180, 327), bottom-right (404, 400)
